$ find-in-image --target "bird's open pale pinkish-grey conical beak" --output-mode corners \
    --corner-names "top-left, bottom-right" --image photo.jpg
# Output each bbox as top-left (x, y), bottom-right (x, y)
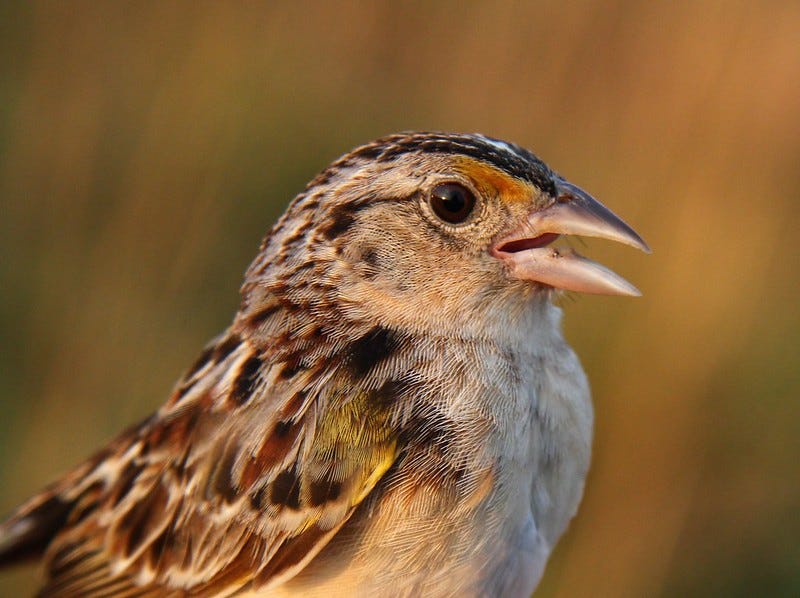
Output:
top-left (492, 179), bottom-right (650, 296)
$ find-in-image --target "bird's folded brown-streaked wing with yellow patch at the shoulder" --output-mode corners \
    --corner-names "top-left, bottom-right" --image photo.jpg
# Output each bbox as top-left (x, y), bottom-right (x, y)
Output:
top-left (0, 334), bottom-right (398, 598)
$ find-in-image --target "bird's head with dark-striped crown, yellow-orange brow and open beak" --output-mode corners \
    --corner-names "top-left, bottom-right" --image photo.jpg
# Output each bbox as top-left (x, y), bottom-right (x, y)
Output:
top-left (244, 133), bottom-right (649, 335)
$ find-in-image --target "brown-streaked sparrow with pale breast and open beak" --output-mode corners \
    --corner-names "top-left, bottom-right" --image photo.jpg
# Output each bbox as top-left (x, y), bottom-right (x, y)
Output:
top-left (0, 132), bottom-right (650, 598)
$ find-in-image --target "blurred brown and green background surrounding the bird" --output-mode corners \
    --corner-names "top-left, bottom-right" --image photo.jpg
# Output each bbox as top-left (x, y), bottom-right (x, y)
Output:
top-left (0, 0), bottom-right (800, 598)
